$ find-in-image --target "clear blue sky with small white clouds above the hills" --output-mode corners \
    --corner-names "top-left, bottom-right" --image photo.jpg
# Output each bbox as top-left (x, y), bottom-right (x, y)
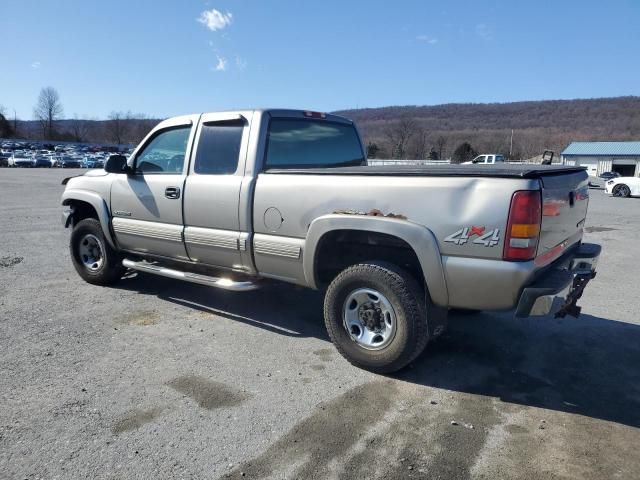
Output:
top-left (0, 0), bottom-right (640, 119)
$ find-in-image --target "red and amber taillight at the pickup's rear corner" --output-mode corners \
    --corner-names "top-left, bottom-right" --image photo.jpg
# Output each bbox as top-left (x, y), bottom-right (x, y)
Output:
top-left (503, 190), bottom-right (542, 261)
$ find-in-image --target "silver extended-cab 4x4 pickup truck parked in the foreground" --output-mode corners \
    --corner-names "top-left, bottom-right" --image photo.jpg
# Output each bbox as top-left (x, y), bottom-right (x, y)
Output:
top-left (62, 110), bottom-right (600, 372)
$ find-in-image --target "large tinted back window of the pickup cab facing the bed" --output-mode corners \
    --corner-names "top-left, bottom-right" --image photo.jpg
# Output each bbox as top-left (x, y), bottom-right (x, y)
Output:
top-left (265, 118), bottom-right (366, 170)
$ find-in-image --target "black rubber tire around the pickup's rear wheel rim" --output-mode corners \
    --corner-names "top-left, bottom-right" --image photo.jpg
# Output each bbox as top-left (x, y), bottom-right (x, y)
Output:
top-left (324, 261), bottom-right (430, 373)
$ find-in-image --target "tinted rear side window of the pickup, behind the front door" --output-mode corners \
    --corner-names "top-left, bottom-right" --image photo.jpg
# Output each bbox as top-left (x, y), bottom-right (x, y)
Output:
top-left (194, 121), bottom-right (244, 175)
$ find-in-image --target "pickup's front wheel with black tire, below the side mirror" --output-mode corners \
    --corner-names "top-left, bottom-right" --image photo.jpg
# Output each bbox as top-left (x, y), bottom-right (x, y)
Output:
top-left (69, 218), bottom-right (125, 285)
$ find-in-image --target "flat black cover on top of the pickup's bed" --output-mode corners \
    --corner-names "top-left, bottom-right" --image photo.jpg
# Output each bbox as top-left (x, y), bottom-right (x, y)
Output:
top-left (265, 164), bottom-right (586, 178)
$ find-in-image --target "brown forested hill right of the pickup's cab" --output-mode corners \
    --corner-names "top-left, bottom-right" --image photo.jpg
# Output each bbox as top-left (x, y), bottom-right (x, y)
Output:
top-left (335, 96), bottom-right (640, 157)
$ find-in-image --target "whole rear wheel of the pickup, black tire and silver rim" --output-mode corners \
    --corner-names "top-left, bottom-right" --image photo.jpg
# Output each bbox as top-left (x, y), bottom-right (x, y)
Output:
top-left (324, 261), bottom-right (429, 373)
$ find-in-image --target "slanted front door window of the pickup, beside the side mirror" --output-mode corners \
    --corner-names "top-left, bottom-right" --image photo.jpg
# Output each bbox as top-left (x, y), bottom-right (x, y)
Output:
top-left (136, 126), bottom-right (191, 174)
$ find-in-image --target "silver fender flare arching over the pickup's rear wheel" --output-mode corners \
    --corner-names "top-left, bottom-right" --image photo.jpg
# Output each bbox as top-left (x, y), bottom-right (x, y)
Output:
top-left (302, 214), bottom-right (449, 307)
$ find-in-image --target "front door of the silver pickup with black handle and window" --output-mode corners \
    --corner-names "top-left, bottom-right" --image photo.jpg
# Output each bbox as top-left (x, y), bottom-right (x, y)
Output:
top-left (111, 115), bottom-right (198, 259)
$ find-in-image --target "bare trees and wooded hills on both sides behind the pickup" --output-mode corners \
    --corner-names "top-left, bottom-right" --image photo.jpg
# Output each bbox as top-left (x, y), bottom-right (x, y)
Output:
top-left (5, 87), bottom-right (640, 162)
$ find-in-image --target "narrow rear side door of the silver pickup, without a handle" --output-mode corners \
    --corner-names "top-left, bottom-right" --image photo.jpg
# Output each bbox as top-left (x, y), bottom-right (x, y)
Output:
top-left (184, 112), bottom-right (252, 270)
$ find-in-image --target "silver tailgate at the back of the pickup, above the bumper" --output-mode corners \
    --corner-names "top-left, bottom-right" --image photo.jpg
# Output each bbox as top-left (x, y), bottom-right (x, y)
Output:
top-left (537, 171), bottom-right (589, 263)
